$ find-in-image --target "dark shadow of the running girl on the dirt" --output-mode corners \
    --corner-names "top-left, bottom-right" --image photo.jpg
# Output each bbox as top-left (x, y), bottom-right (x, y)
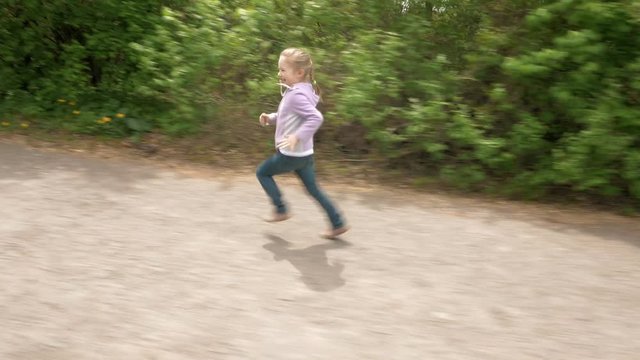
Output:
top-left (262, 234), bottom-right (349, 291)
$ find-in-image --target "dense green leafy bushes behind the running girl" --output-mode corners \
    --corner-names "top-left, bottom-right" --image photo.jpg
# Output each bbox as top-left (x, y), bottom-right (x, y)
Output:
top-left (0, 0), bottom-right (640, 206)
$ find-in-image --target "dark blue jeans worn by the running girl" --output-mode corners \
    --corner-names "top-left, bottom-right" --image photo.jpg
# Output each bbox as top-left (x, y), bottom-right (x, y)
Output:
top-left (256, 152), bottom-right (344, 229)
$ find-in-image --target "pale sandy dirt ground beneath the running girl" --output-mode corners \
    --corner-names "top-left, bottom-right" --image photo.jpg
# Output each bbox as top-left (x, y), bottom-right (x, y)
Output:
top-left (0, 140), bottom-right (640, 360)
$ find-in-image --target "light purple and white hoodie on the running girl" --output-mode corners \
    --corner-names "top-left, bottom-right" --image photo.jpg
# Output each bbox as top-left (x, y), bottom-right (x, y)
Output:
top-left (269, 83), bottom-right (324, 157)
